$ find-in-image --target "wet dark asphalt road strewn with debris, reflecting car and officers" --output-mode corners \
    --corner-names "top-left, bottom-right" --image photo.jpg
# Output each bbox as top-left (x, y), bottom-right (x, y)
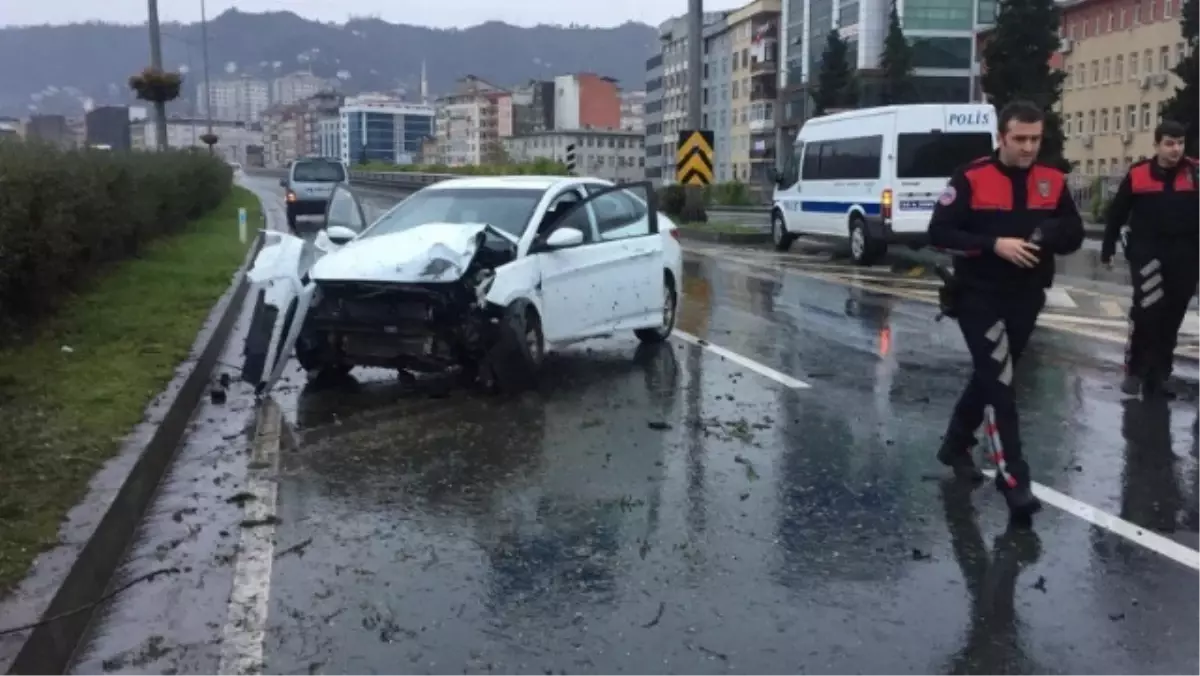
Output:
top-left (65, 176), bottom-right (1200, 676)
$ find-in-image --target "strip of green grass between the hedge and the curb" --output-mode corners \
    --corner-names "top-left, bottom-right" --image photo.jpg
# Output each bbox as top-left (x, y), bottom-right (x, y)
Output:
top-left (0, 187), bottom-right (262, 593)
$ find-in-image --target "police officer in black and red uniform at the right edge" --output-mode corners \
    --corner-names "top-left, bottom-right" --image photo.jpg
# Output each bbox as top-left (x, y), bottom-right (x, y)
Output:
top-left (1100, 121), bottom-right (1200, 397)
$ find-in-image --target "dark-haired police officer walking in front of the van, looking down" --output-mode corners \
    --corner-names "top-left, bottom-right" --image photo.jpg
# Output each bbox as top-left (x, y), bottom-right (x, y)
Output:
top-left (929, 101), bottom-right (1084, 518)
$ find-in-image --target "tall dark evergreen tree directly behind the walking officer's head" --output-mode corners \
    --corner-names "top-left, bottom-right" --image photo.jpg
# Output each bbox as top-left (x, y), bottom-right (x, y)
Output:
top-left (982, 0), bottom-right (1069, 169)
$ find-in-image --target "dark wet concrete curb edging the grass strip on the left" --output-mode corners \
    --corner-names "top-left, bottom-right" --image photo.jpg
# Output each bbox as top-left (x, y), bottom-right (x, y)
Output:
top-left (8, 202), bottom-right (263, 676)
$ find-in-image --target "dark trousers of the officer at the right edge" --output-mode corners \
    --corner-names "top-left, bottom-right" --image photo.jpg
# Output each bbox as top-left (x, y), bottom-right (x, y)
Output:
top-left (1126, 249), bottom-right (1200, 382)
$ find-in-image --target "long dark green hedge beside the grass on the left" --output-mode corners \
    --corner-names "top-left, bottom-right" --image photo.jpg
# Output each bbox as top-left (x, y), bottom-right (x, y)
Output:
top-left (0, 140), bottom-right (232, 342)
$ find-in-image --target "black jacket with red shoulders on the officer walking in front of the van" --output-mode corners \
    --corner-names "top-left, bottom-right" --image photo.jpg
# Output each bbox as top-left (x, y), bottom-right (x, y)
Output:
top-left (929, 154), bottom-right (1084, 291)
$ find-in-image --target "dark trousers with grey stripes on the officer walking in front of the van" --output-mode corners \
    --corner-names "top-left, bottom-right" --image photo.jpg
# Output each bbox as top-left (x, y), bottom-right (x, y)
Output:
top-left (946, 287), bottom-right (1046, 487)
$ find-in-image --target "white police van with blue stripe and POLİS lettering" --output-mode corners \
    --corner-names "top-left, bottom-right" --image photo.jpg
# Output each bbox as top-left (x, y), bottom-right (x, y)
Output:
top-left (770, 103), bottom-right (996, 265)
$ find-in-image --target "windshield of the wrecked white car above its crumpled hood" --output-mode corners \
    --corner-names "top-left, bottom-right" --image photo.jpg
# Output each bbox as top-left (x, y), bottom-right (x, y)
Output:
top-left (360, 187), bottom-right (544, 239)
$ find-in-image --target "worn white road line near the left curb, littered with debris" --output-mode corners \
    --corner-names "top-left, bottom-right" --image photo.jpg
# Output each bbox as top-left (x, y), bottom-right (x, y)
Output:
top-left (217, 399), bottom-right (283, 676)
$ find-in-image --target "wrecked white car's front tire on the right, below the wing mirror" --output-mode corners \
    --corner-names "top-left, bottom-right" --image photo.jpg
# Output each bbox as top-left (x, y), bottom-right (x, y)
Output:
top-left (480, 301), bottom-right (546, 394)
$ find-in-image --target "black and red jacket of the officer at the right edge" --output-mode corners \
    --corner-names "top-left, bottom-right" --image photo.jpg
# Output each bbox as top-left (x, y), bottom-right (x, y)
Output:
top-left (1100, 157), bottom-right (1200, 262)
